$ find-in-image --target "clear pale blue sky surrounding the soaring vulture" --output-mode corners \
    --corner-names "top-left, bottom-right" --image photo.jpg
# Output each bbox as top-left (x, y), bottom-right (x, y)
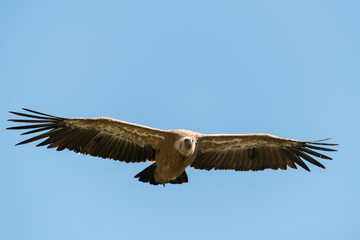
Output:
top-left (0, 0), bottom-right (360, 240)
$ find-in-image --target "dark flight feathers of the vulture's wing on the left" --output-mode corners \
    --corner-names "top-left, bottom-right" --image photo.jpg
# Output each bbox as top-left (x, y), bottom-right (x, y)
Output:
top-left (7, 108), bottom-right (156, 162)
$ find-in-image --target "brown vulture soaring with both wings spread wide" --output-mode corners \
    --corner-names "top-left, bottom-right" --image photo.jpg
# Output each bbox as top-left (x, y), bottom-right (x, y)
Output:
top-left (7, 108), bottom-right (337, 185)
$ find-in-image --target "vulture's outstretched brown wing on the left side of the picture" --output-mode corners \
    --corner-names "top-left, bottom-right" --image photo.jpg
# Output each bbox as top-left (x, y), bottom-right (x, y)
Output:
top-left (7, 108), bottom-right (167, 162)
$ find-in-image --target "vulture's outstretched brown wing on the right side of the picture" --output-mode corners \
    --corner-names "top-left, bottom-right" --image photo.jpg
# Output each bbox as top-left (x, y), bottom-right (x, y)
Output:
top-left (191, 134), bottom-right (337, 171)
